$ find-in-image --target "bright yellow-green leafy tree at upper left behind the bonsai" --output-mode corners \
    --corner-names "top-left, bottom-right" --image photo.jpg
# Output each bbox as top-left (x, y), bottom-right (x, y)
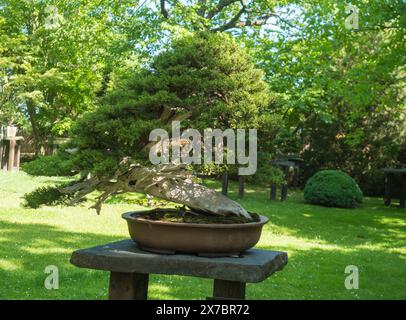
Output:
top-left (0, 0), bottom-right (152, 152)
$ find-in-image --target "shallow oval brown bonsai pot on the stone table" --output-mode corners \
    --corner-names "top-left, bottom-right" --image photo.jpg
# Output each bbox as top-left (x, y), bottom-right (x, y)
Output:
top-left (122, 210), bottom-right (268, 256)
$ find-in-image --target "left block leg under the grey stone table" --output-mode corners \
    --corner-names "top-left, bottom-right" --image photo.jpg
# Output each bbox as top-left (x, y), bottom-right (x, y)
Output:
top-left (109, 272), bottom-right (149, 300)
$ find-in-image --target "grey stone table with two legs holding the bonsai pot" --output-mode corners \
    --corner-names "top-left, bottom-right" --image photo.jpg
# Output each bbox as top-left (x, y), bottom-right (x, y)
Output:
top-left (70, 240), bottom-right (288, 300)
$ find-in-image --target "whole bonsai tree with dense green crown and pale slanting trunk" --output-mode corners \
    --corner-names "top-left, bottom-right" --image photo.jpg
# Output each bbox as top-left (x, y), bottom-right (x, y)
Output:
top-left (23, 33), bottom-right (269, 219)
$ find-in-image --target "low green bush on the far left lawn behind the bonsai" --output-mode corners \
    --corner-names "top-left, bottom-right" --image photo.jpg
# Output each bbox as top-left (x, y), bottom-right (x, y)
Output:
top-left (22, 154), bottom-right (74, 177)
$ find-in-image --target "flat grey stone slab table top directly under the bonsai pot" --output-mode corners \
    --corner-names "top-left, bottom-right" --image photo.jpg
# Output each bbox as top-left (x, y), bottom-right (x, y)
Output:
top-left (70, 240), bottom-right (288, 282)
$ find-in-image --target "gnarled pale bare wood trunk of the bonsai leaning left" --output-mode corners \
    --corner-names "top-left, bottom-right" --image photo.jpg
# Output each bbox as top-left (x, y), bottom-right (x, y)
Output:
top-left (60, 164), bottom-right (251, 219)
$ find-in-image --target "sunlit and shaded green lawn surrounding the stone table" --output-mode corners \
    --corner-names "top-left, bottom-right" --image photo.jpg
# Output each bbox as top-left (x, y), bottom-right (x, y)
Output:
top-left (0, 172), bottom-right (406, 299)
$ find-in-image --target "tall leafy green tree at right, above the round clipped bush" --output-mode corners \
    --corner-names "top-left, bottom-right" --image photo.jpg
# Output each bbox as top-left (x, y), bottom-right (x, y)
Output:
top-left (256, 1), bottom-right (406, 194)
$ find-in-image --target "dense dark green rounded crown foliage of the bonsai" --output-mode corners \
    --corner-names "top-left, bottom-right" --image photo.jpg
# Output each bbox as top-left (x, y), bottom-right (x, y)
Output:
top-left (68, 32), bottom-right (270, 175)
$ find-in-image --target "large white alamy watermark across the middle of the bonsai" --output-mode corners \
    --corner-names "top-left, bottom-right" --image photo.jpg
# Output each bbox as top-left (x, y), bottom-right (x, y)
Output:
top-left (149, 121), bottom-right (257, 175)
